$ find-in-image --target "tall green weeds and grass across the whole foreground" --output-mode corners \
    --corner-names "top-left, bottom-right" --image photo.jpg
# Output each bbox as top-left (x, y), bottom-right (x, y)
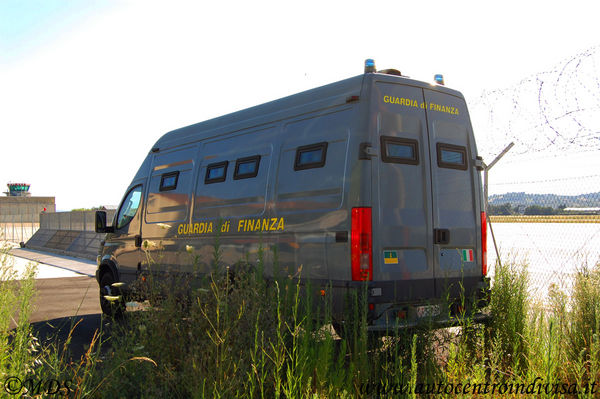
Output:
top-left (0, 242), bottom-right (600, 399)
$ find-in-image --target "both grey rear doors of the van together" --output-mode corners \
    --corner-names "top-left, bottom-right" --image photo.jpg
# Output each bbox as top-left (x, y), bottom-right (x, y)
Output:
top-left (371, 82), bottom-right (481, 301)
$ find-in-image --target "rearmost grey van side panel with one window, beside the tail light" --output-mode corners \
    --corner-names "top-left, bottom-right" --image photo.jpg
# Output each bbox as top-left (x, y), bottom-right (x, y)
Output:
top-left (274, 107), bottom-right (353, 282)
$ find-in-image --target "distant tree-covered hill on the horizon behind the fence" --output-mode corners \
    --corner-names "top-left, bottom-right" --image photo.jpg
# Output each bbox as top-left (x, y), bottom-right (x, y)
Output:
top-left (488, 192), bottom-right (600, 208)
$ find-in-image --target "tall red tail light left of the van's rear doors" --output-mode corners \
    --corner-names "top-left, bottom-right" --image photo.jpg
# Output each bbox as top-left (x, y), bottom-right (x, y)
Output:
top-left (350, 207), bottom-right (373, 281)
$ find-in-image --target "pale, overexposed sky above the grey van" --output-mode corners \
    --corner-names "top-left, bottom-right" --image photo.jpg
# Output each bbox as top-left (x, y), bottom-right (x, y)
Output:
top-left (0, 0), bottom-right (600, 210)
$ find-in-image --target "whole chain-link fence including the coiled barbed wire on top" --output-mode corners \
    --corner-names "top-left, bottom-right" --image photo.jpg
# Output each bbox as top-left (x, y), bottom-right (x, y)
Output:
top-left (470, 47), bottom-right (600, 304)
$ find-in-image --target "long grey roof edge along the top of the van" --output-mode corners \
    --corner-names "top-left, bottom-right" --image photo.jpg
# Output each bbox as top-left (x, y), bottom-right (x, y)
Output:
top-left (152, 73), bottom-right (463, 151)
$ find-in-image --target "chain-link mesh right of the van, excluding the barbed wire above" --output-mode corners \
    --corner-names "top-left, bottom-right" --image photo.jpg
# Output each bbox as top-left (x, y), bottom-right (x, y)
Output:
top-left (488, 175), bottom-right (600, 297)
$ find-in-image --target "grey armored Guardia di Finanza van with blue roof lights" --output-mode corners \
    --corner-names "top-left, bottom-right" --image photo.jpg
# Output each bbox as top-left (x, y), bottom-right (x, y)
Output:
top-left (96, 60), bottom-right (487, 329)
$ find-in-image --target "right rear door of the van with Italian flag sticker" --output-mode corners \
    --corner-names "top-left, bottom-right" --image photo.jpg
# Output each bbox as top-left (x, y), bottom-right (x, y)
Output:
top-left (424, 90), bottom-right (481, 296)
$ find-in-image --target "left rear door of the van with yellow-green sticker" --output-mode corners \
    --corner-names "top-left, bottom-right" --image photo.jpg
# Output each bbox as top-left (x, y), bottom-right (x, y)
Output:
top-left (371, 82), bottom-right (435, 300)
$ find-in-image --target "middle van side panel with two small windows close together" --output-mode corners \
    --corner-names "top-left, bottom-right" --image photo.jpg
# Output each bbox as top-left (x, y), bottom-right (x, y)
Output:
top-left (188, 124), bottom-right (280, 273)
